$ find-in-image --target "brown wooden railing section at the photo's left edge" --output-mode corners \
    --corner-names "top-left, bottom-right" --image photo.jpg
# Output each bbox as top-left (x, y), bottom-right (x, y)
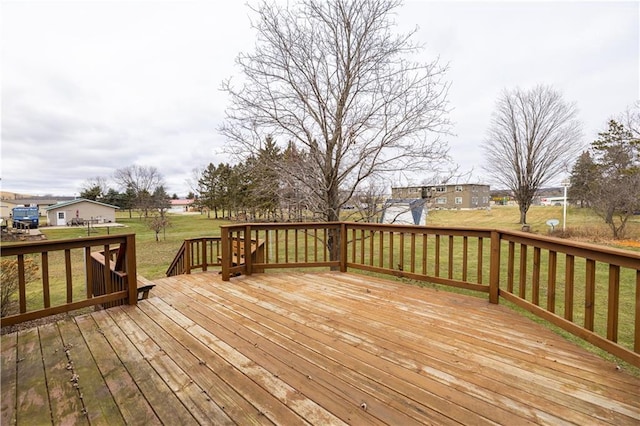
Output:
top-left (1, 234), bottom-right (137, 327)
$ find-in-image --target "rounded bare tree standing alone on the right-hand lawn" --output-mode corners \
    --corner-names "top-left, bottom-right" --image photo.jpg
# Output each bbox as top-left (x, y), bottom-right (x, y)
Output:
top-left (483, 86), bottom-right (582, 224)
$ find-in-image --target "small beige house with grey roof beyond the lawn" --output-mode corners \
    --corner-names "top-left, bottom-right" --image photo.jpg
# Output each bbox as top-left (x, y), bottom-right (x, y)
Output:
top-left (44, 198), bottom-right (119, 226)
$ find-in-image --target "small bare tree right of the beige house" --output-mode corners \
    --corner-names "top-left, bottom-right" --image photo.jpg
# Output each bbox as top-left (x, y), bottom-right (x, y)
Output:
top-left (113, 164), bottom-right (164, 217)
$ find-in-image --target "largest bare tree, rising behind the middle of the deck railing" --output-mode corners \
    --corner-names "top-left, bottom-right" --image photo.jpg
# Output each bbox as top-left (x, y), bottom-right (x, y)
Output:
top-left (221, 0), bottom-right (449, 253)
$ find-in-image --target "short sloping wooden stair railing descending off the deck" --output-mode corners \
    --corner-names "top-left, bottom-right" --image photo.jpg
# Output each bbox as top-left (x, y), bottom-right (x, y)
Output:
top-left (166, 237), bottom-right (222, 277)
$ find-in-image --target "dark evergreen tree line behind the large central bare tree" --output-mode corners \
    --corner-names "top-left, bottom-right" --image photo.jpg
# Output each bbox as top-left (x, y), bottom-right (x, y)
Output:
top-left (193, 137), bottom-right (385, 221)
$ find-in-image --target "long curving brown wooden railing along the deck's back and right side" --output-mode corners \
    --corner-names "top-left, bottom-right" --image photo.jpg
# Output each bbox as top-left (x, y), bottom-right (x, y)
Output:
top-left (221, 222), bottom-right (640, 367)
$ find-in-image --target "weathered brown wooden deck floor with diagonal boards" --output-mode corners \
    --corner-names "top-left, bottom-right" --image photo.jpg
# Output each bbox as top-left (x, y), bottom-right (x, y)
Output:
top-left (1, 272), bottom-right (640, 425)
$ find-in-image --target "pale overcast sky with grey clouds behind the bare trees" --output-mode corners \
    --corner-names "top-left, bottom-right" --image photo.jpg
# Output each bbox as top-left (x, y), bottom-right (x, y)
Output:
top-left (0, 0), bottom-right (640, 196)
